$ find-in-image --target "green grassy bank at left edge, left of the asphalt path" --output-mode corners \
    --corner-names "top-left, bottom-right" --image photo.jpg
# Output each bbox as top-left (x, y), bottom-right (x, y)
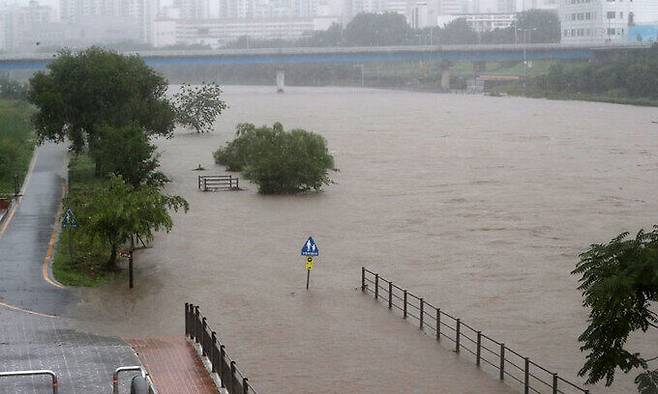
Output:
top-left (0, 99), bottom-right (35, 195)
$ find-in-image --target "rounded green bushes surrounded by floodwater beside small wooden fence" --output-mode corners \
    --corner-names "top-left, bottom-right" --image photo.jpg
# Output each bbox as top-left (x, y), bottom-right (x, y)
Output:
top-left (213, 123), bottom-right (334, 194)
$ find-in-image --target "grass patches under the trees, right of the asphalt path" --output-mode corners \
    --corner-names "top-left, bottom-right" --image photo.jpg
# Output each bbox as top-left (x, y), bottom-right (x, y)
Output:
top-left (53, 154), bottom-right (121, 287)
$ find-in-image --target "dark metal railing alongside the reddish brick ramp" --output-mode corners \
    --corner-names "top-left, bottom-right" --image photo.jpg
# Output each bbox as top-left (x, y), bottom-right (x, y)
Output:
top-left (185, 302), bottom-right (258, 394)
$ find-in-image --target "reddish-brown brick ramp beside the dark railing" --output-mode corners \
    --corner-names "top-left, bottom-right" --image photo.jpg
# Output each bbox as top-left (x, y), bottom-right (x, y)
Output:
top-left (127, 336), bottom-right (217, 394)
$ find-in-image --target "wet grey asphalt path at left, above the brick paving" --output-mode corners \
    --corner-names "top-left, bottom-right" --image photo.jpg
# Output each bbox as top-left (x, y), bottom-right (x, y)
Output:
top-left (0, 144), bottom-right (75, 315)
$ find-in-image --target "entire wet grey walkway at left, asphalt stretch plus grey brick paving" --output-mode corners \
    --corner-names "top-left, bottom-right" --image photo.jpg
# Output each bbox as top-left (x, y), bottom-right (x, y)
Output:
top-left (0, 144), bottom-right (139, 394)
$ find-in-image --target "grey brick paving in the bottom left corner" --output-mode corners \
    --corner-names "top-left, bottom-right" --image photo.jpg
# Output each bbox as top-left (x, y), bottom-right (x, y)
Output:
top-left (0, 308), bottom-right (139, 394)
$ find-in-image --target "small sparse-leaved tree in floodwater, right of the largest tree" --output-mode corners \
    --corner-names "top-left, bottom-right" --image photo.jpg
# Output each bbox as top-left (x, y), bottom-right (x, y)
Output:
top-left (173, 82), bottom-right (228, 133)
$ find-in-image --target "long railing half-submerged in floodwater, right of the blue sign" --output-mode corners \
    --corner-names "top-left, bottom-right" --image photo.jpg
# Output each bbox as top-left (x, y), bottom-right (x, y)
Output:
top-left (361, 267), bottom-right (590, 394)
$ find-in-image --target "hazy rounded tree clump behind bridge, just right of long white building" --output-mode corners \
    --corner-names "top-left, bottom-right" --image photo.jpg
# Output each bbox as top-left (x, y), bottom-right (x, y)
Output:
top-left (343, 12), bottom-right (411, 46)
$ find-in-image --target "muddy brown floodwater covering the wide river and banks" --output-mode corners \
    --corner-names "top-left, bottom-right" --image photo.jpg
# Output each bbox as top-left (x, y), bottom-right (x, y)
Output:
top-left (71, 87), bottom-right (658, 393)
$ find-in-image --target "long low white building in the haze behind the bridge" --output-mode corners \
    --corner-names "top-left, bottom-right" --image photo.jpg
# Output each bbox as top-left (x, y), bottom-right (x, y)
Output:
top-left (153, 17), bottom-right (338, 48)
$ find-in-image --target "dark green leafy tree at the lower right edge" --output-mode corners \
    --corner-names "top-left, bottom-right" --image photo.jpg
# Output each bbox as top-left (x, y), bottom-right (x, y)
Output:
top-left (572, 226), bottom-right (658, 385)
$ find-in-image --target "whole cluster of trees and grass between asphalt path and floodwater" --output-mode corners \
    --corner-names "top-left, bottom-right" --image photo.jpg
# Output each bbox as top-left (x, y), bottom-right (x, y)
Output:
top-left (28, 48), bottom-right (225, 285)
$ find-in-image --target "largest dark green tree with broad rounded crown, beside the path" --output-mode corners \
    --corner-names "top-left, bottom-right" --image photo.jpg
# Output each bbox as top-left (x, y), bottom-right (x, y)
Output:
top-left (28, 47), bottom-right (175, 159)
